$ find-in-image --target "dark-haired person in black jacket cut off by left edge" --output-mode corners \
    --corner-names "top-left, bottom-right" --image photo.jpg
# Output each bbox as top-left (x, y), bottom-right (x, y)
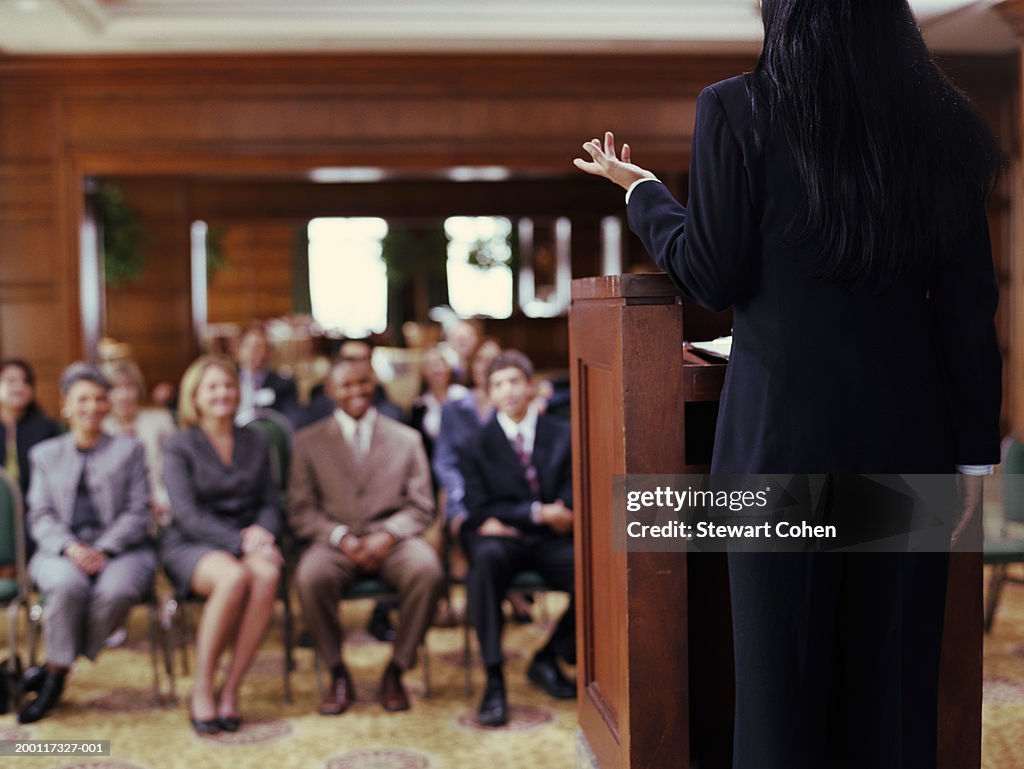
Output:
top-left (0, 358), bottom-right (60, 505)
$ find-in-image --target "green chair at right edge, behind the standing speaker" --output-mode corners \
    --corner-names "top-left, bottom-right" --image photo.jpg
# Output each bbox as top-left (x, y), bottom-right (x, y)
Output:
top-left (984, 437), bottom-right (1024, 633)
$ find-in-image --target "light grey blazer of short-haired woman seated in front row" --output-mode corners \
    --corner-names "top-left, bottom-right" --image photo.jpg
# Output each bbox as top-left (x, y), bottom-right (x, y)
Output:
top-left (28, 433), bottom-right (151, 555)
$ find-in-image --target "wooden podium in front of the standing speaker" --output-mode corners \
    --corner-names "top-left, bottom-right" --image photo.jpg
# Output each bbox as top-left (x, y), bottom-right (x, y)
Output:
top-left (569, 274), bottom-right (982, 769)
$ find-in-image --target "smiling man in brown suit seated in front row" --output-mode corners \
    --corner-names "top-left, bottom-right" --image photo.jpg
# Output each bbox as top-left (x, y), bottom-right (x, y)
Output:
top-left (289, 359), bottom-right (444, 715)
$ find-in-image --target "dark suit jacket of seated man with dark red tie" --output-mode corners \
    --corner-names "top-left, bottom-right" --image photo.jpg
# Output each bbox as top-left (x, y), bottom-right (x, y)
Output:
top-left (458, 414), bottom-right (572, 535)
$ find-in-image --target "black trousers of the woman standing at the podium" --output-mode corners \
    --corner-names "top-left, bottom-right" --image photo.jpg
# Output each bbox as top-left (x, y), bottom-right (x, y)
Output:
top-left (729, 553), bottom-right (949, 769)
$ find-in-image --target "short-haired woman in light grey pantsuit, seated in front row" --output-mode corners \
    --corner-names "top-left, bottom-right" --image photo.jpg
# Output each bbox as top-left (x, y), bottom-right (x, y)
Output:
top-left (18, 364), bottom-right (157, 724)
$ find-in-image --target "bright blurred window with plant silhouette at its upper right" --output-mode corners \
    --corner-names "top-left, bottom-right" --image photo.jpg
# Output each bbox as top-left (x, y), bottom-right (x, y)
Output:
top-left (444, 216), bottom-right (512, 317)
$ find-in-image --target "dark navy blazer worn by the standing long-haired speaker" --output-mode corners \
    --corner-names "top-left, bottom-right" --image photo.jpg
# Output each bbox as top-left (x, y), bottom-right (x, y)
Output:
top-left (628, 77), bottom-right (1000, 473)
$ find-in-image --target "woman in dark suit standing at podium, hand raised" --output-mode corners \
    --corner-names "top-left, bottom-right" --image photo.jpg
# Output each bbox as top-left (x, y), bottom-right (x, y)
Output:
top-left (575, 0), bottom-right (1000, 769)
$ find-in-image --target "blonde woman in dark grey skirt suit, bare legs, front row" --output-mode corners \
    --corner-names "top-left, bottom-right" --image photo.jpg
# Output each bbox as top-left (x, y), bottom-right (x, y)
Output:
top-left (162, 355), bottom-right (284, 734)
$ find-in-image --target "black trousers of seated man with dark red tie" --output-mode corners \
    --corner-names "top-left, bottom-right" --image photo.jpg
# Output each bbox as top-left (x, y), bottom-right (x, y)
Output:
top-left (462, 531), bottom-right (575, 668)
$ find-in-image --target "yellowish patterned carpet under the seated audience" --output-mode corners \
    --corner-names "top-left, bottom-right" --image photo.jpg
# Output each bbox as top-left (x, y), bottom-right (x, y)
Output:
top-left (8, 585), bottom-right (1024, 769)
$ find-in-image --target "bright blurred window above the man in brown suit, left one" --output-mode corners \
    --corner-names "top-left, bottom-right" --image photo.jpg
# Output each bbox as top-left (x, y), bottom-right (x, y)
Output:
top-left (308, 217), bottom-right (387, 337)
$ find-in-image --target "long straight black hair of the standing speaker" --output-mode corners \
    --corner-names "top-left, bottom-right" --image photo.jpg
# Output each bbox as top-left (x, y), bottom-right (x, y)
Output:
top-left (749, 0), bottom-right (999, 289)
